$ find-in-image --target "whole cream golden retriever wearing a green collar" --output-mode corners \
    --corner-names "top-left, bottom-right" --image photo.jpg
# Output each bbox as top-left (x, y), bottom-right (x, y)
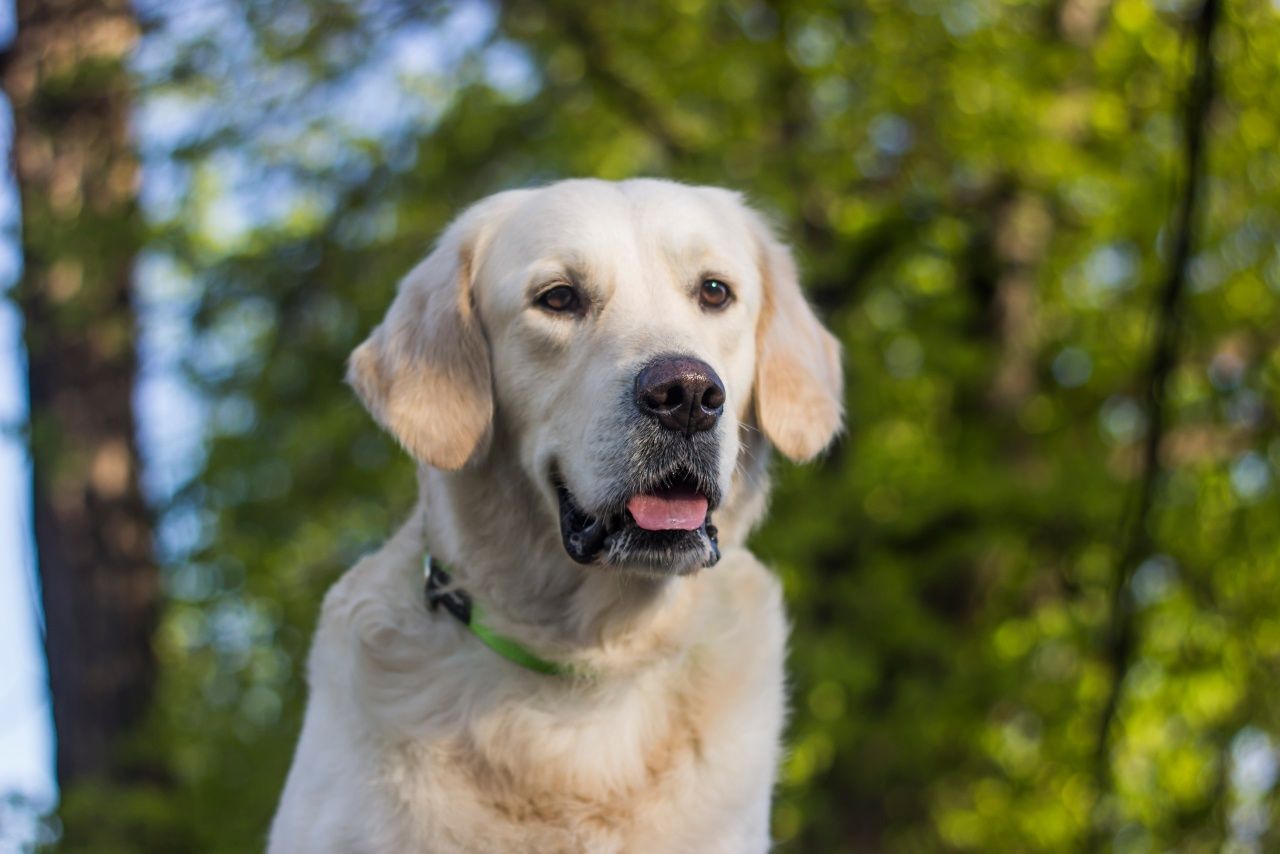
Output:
top-left (269, 179), bottom-right (844, 854)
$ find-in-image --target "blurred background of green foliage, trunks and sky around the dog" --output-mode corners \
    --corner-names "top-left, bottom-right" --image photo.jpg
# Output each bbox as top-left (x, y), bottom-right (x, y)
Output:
top-left (0, 0), bottom-right (1280, 851)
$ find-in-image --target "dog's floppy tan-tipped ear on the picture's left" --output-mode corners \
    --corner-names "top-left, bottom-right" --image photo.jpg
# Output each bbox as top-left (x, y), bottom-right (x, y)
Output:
top-left (347, 191), bottom-right (524, 471)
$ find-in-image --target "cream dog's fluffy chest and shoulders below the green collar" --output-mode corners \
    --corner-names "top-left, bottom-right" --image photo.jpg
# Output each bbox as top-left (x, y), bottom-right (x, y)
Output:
top-left (271, 524), bottom-right (785, 851)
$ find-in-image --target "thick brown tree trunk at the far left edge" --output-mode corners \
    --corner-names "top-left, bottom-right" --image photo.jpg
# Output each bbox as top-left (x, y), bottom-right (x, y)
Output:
top-left (4, 0), bottom-right (159, 787)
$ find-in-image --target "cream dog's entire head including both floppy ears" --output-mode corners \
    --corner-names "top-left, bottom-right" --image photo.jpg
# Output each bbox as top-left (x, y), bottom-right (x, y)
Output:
top-left (349, 181), bottom-right (841, 574)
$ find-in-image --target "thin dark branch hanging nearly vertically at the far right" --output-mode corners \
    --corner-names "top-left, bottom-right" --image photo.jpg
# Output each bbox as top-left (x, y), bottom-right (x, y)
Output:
top-left (1091, 0), bottom-right (1220, 849)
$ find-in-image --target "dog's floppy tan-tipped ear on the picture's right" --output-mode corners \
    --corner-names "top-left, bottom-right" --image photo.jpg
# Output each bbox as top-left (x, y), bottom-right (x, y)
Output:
top-left (748, 211), bottom-right (845, 462)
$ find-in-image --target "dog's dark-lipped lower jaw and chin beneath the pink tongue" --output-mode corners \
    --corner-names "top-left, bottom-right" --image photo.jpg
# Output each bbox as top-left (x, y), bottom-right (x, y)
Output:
top-left (556, 473), bottom-right (719, 576)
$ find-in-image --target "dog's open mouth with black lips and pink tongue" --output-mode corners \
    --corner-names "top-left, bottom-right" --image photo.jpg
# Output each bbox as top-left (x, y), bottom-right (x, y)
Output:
top-left (553, 467), bottom-right (719, 575)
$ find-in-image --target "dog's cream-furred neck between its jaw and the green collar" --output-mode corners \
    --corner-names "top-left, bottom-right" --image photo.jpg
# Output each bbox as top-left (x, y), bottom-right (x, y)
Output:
top-left (416, 430), bottom-right (767, 668)
